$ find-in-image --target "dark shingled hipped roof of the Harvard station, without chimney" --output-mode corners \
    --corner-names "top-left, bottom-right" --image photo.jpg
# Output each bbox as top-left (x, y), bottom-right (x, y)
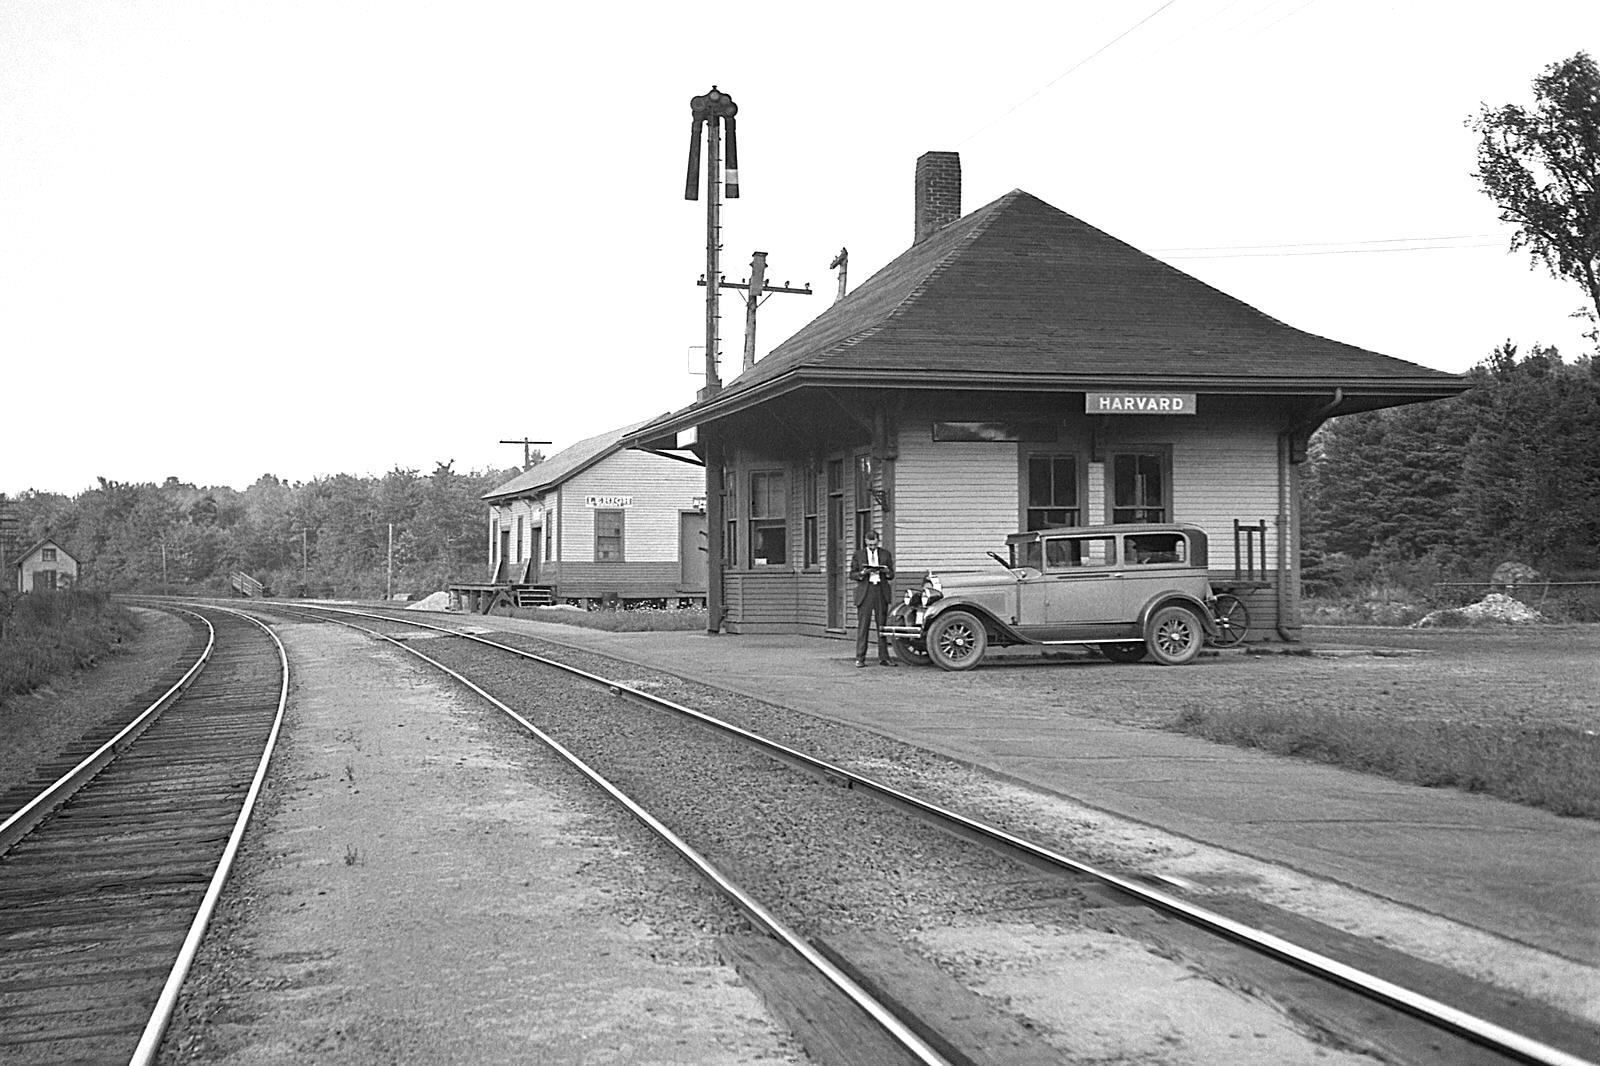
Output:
top-left (617, 189), bottom-right (1470, 443)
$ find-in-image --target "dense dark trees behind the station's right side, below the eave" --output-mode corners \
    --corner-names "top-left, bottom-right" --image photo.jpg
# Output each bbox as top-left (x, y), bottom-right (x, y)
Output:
top-left (1302, 341), bottom-right (1600, 592)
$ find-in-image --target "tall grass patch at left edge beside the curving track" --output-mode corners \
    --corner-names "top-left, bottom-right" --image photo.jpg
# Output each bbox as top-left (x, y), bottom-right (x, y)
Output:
top-left (0, 591), bottom-right (138, 703)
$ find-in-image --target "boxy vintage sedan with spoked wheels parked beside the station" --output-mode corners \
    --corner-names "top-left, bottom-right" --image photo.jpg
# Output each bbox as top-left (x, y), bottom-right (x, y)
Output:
top-left (883, 525), bottom-right (1214, 671)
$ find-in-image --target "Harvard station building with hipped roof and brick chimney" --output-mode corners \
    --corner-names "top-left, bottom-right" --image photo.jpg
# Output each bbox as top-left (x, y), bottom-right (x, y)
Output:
top-left (622, 152), bottom-right (1469, 639)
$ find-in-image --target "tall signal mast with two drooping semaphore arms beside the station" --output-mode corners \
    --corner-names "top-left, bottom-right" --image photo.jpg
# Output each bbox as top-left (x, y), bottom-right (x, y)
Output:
top-left (683, 85), bottom-right (739, 634)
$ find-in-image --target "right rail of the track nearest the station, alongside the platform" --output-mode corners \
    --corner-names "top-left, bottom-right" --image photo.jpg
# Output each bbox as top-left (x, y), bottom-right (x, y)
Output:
top-left (297, 608), bottom-right (1600, 1066)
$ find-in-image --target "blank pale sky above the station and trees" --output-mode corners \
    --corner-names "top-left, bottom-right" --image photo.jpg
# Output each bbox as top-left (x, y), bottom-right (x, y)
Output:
top-left (0, 0), bottom-right (1600, 495)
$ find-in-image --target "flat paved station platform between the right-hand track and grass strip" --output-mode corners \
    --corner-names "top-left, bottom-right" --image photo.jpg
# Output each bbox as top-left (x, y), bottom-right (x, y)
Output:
top-left (432, 616), bottom-right (1600, 985)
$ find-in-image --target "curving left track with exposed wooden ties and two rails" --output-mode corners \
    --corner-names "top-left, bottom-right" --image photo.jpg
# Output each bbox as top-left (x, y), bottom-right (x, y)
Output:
top-left (0, 607), bottom-right (288, 1064)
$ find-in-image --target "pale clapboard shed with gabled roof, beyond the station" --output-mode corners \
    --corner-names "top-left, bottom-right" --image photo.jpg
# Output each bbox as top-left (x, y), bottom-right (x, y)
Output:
top-left (450, 426), bottom-right (707, 613)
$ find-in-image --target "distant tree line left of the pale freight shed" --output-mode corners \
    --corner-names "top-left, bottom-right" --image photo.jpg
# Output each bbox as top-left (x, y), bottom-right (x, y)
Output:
top-left (8, 461), bottom-right (518, 597)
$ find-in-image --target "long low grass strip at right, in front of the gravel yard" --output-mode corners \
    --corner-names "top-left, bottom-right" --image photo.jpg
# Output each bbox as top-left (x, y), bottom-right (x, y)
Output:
top-left (1171, 704), bottom-right (1600, 818)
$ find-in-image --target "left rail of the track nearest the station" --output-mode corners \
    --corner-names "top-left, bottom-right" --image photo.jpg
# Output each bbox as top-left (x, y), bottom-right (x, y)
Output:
top-left (283, 603), bottom-right (952, 1066)
